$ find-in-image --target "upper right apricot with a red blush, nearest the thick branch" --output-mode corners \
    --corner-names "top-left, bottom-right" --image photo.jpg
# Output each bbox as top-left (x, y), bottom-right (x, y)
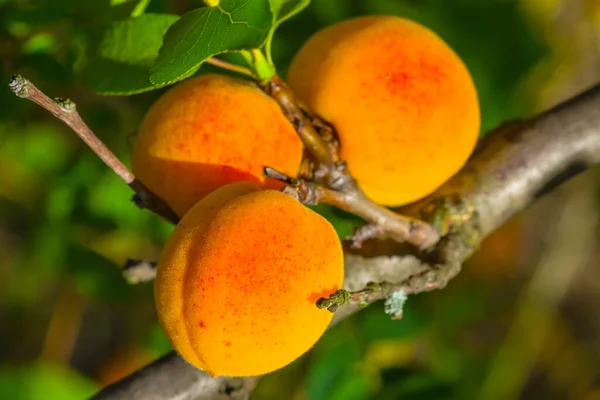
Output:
top-left (288, 16), bottom-right (480, 206)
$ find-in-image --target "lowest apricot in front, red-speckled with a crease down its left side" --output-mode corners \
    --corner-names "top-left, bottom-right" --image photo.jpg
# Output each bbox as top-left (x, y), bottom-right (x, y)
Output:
top-left (154, 182), bottom-right (344, 376)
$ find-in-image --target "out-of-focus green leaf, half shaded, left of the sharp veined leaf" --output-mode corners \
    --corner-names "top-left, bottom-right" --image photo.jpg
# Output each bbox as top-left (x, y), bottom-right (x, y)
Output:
top-left (82, 13), bottom-right (180, 95)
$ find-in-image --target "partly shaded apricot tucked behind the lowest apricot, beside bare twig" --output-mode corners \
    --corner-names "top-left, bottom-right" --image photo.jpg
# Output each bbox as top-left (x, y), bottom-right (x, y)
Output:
top-left (132, 74), bottom-right (302, 216)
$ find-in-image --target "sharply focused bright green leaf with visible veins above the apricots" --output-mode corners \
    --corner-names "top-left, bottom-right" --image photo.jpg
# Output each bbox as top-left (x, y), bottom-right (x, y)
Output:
top-left (150, 0), bottom-right (274, 85)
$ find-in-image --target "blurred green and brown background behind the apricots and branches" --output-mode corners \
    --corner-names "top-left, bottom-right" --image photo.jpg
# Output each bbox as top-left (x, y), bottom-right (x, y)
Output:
top-left (0, 0), bottom-right (600, 400)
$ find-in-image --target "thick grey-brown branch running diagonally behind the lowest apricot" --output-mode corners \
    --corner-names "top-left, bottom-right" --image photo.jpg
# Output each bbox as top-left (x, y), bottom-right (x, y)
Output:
top-left (88, 85), bottom-right (600, 400)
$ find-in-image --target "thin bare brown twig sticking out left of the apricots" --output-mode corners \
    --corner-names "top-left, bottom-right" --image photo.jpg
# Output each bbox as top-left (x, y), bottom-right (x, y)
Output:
top-left (8, 75), bottom-right (179, 224)
